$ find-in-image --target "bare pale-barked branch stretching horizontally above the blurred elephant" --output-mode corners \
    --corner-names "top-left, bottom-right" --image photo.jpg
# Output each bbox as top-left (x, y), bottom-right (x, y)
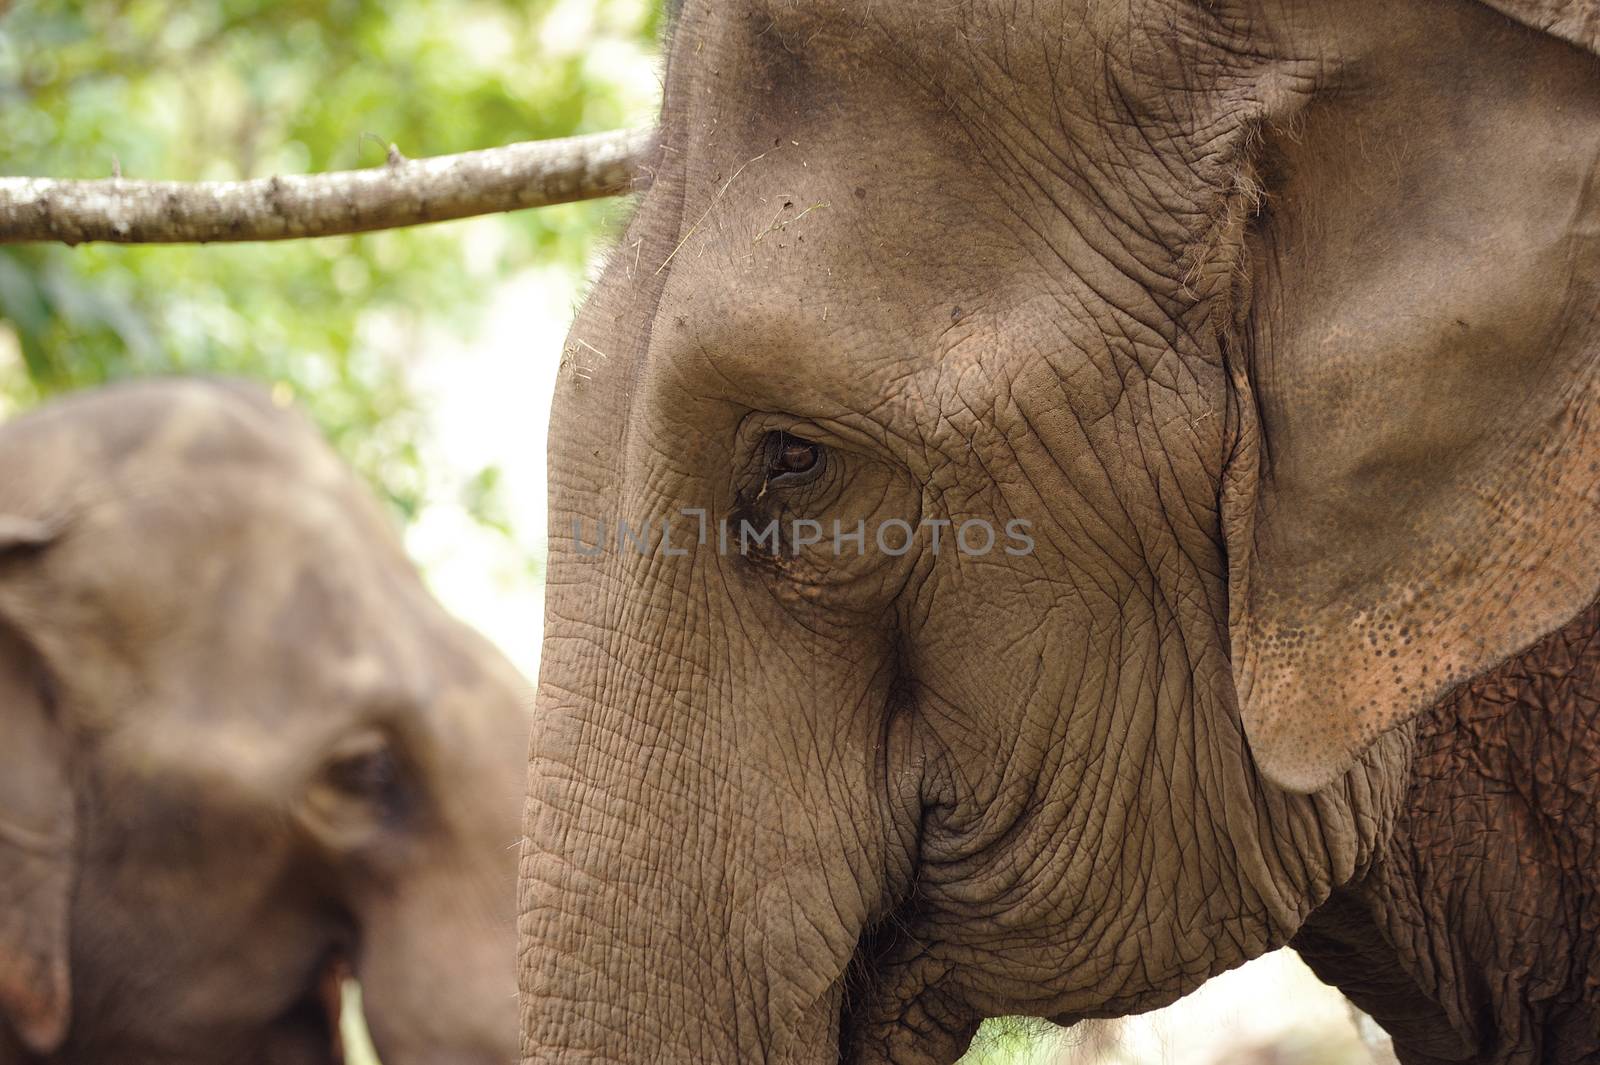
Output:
top-left (0, 128), bottom-right (654, 245)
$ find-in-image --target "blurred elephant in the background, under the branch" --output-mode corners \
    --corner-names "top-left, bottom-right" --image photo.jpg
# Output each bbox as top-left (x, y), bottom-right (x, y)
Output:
top-left (0, 379), bottom-right (533, 1065)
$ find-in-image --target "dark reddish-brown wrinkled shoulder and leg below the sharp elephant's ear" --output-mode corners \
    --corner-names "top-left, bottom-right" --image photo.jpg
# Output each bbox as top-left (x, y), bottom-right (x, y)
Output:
top-left (1293, 606), bottom-right (1600, 1063)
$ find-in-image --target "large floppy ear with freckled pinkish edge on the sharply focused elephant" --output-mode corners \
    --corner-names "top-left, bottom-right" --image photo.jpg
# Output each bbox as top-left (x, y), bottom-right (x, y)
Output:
top-left (1222, 0), bottom-right (1600, 792)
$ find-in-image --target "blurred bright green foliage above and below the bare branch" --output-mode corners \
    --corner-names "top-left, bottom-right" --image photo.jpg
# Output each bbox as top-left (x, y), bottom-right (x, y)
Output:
top-left (0, 0), bottom-right (656, 528)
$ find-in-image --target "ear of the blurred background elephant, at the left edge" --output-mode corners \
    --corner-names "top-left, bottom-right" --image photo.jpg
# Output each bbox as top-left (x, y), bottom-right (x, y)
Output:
top-left (0, 515), bottom-right (75, 1054)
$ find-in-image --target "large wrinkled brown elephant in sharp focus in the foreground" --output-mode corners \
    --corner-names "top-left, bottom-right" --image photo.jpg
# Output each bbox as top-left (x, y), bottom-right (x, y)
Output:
top-left (518, 0), bottom-right (1600, 1065)
